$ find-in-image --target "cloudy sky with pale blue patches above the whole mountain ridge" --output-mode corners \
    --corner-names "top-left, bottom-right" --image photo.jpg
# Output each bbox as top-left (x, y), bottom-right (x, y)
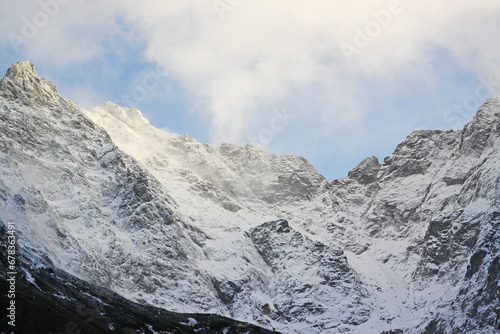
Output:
top-left (0, 0), bottom-right (500, 180)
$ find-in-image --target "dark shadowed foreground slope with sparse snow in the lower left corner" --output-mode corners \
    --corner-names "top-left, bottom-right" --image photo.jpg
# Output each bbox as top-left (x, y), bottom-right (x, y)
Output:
top-left (0, 221), bottom-right (274, 334)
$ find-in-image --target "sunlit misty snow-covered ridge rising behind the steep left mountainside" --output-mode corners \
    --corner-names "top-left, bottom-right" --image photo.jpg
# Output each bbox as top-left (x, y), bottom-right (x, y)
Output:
top-left (85, 103), bottom-right (328, 219)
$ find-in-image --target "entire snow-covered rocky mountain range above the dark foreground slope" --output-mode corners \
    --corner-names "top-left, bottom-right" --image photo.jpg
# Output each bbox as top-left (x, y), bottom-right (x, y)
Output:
top-left (0, 62), bottom-right (500, 333)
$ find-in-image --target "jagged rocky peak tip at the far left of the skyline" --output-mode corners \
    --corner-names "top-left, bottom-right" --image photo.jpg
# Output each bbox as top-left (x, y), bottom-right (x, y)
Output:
top-left (0, 61), bottom-right (65, 106)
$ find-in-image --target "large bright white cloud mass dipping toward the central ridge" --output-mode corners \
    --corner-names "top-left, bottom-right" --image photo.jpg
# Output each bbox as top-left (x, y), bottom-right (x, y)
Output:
top-left (112, 0), bottom-right (500, 141)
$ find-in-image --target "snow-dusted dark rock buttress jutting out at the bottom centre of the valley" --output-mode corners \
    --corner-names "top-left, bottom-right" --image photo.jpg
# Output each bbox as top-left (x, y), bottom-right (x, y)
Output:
top-left (250, 220), bottom-right (370, 332)
